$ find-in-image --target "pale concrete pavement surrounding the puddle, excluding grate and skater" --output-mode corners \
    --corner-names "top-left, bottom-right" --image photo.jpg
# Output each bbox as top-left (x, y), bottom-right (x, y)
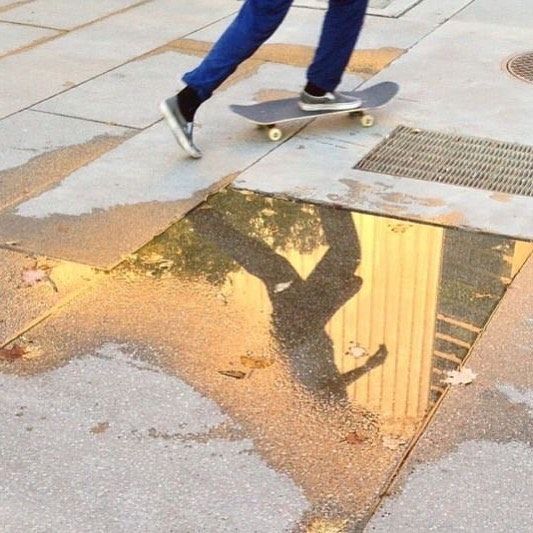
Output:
top-left (0, 0), bottom-right (533, 532)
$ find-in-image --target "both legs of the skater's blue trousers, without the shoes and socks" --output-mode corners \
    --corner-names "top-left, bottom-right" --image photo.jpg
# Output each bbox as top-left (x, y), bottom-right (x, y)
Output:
top-left (183, 0), bottom-right (368, 100)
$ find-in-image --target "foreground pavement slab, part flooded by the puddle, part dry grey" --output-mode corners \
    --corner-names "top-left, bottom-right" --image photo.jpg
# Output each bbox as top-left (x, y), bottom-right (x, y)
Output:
top-left (2, 190), bottom-right (531, 531)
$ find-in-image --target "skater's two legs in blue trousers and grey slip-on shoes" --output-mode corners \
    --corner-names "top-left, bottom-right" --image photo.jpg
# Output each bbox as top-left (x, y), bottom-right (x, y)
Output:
top-left (161, 0), bottom-right (368, 158)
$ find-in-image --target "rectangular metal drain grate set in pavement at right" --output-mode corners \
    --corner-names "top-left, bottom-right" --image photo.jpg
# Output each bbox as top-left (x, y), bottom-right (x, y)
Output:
top-left (355, 126), bottom-right (533, 197)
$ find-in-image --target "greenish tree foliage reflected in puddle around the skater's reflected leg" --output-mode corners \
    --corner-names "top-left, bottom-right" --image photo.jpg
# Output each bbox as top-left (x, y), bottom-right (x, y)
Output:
top-left (140, 190), bottom-right (323, 284)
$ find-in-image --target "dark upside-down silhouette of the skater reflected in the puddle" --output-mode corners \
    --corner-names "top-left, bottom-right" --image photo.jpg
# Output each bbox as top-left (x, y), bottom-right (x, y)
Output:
top-left (189, 202), bottom-right (387, 399)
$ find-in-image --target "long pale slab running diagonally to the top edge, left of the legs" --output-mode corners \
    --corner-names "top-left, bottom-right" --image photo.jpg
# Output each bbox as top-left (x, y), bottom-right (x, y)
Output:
top-left (0, 0), bottom-right (235, 118)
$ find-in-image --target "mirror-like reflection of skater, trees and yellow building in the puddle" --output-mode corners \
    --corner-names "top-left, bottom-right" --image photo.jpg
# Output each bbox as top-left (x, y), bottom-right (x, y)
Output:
top-left (134, 191), bottom-right (531, 436)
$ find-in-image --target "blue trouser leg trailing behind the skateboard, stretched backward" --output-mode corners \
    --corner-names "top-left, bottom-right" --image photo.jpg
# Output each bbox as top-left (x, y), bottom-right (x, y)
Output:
top-left (183, 0), bottom-right (293, 100)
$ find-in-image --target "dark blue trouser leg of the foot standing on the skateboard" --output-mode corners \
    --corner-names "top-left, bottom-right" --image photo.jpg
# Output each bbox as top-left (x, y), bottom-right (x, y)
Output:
top-left (307, 0), bottom-right (368, 91)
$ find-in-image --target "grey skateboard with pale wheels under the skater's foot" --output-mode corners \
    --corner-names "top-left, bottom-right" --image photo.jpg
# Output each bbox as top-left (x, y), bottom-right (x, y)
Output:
top-left (230, 81), bottom-right (400, 141)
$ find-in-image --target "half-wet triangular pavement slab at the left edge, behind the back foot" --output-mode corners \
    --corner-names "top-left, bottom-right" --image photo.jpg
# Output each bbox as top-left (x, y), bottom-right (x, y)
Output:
top-left (0, 111), bottom-right (133, 210)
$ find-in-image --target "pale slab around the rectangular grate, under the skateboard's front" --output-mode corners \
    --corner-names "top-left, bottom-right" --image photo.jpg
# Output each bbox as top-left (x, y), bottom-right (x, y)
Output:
top-left (235, 18), bottom-right (533, 240)
